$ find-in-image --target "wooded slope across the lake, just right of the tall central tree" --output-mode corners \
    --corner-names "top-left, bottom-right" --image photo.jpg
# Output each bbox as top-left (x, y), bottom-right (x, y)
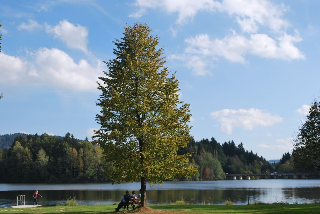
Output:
top-left (184, 138), bottom-right (274, 176)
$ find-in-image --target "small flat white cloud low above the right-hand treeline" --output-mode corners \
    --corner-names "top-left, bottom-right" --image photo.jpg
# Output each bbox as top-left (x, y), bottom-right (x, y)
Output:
top-left (210, 108), bottom-right (282, 134)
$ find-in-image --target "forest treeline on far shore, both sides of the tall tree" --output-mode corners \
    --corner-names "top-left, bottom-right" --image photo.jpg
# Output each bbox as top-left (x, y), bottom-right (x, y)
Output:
top-left (0, 133), bottom-right (294, 183)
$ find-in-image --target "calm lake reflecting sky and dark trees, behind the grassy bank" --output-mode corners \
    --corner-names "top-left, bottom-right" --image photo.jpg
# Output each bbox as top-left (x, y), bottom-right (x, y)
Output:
top-left (0, 179), bottom-right (320, 207)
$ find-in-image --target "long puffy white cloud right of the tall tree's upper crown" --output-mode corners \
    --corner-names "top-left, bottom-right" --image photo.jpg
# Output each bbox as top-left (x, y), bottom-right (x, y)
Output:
top-left (170, 31), bottom-right (305, 76)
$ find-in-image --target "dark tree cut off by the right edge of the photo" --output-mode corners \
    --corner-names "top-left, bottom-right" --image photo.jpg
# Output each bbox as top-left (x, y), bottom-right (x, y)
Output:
top-left (292, 101), bottom-right (320, 172)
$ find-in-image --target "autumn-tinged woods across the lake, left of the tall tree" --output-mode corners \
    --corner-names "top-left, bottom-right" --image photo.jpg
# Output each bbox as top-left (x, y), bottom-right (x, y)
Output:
top-left (0, 133), bottom-right (109, 183)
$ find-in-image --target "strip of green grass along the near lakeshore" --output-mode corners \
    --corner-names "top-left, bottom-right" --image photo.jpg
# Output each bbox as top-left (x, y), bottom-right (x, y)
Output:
top-left (0, 204), bottom-right (320, 214)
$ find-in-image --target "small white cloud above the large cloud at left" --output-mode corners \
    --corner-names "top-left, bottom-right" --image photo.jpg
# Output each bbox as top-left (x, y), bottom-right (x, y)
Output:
top-left (46, 20), bottom-right (88, 53)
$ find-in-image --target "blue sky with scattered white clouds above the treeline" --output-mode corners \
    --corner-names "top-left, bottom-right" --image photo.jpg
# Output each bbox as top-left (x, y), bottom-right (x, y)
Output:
top-left (0, 0), bottom-right (320, 159)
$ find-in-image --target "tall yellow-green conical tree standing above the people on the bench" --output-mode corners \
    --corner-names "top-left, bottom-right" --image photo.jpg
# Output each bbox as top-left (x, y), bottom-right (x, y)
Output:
top-left (94, 24), bottom-right (195, 206)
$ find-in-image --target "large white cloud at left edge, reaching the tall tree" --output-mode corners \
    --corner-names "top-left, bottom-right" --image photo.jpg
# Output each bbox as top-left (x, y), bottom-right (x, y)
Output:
top-left (0, 48), bottom-right (104, 91)
